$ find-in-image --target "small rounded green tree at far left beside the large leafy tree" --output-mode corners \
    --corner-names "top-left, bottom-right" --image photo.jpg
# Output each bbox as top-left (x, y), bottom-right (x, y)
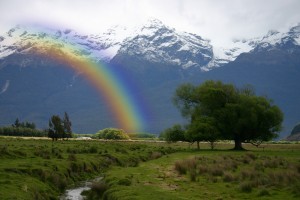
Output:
top-left (161, 124), bottom-right (185, 142)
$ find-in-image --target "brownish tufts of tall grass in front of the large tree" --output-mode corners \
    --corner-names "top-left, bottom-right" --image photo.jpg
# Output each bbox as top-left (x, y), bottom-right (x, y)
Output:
top-left (174, 153), bottom-right (300, 196)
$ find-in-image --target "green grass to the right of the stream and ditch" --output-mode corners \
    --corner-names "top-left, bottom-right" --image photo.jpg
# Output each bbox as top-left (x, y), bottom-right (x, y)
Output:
top-left (104, 144), bottom-right (300, 199)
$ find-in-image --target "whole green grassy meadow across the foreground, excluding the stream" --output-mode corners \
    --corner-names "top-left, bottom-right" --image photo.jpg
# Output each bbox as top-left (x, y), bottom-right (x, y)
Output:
top-left (0, 137), bottom-right (300, 199)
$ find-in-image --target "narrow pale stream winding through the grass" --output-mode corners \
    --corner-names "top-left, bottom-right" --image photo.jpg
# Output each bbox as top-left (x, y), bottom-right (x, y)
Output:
top-left (60, 177), bottom-right (103, 200)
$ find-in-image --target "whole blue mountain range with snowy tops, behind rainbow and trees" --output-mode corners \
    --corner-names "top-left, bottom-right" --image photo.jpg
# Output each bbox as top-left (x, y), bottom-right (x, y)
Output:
top-left (0, 19), bottom-right (300, 137)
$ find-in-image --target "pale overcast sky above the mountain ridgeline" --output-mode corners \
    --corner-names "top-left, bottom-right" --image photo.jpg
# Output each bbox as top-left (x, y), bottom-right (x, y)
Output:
top-left (0, 0), bottom-right (300, 45)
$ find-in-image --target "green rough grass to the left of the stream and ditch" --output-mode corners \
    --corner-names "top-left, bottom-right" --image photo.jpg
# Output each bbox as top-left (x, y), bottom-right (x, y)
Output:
top-left (0, 137), bottom-right (179, 200)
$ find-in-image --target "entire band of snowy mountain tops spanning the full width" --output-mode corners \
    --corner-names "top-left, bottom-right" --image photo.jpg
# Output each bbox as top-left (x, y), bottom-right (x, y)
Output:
top-left (0, 19), bottom-right (300, 71)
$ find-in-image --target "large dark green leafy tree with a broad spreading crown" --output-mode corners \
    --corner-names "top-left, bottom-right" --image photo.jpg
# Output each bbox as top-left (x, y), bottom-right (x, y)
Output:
top-left (174, 81), bottom-right (283, 149)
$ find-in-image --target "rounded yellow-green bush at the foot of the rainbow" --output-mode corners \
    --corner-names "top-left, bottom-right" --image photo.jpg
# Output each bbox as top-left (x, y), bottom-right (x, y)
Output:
top-left (97, 128), bottom-right (129, 140)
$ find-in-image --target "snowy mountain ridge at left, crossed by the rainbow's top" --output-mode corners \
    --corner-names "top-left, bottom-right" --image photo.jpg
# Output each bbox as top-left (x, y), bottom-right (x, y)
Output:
top-left (0, 25), bottom-right (126, 61)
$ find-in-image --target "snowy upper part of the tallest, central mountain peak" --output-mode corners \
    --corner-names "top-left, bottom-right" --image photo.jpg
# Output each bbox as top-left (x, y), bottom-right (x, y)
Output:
top-left (118, 20), bottom-right (213, 68)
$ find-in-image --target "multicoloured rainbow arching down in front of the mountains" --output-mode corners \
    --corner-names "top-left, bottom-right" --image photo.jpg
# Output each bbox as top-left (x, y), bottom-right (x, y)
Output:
top-left (24, 26), bottom-right (147, 132)
